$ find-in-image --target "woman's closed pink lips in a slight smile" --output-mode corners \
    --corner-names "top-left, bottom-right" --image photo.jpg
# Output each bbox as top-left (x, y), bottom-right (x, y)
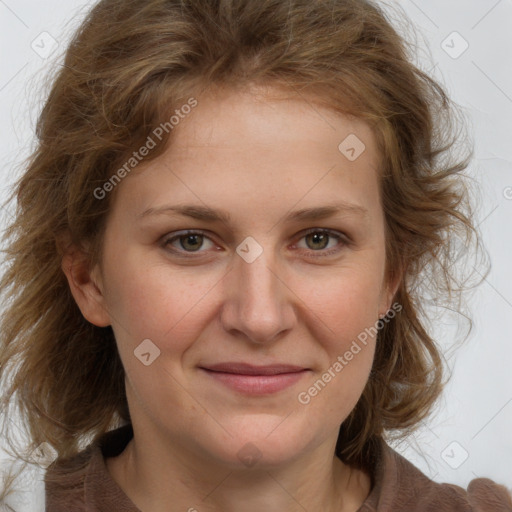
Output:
top-left (200, 362), bottom-right (310, 395)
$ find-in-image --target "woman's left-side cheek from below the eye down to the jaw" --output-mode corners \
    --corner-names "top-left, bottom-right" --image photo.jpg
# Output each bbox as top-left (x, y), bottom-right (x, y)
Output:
top-left (102, 256), bottom-right (219, 429)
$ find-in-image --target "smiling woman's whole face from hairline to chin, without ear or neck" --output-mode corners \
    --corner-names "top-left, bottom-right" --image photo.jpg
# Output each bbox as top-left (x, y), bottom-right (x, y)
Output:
top-left (85, 89), bottom-right (395, 465)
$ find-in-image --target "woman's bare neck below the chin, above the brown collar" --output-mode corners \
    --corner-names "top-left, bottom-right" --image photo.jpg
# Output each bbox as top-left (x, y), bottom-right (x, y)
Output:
top-left (107, 426), bottom-right (370, 512)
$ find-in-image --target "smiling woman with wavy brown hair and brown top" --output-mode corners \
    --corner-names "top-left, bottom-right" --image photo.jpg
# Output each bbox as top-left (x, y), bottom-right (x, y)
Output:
top-left (1, 0), bottom-right (512, 512)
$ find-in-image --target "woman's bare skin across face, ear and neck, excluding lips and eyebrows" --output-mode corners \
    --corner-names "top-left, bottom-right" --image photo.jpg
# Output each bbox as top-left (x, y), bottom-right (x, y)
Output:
top-left (63, 87), bottom-right (398, 512)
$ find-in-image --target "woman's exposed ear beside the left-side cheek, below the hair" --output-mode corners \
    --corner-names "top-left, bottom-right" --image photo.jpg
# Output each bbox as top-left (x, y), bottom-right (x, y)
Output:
top-left (61, 238), bottom-right (111, 327)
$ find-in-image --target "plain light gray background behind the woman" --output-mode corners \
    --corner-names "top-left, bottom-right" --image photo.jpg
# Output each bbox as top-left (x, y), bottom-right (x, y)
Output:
top-left (0, 0), bottom-right (512, 512)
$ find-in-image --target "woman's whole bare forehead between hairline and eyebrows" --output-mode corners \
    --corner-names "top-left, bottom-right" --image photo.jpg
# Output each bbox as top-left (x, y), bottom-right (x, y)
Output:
top-left (113, 89), bottom-right (379, 222)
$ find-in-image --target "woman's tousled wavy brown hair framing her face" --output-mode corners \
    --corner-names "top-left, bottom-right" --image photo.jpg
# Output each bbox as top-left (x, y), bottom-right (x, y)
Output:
top-left (0, 0), bottom-right (478, 494)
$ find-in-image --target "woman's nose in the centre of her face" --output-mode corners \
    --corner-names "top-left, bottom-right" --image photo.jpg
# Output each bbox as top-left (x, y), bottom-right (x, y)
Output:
top-left (221, 243), bottom-right (297, 344)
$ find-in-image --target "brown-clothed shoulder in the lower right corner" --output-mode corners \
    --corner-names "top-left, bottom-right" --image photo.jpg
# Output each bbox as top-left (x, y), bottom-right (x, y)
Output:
top-left (358, 441), bottom-right (512, 512)
